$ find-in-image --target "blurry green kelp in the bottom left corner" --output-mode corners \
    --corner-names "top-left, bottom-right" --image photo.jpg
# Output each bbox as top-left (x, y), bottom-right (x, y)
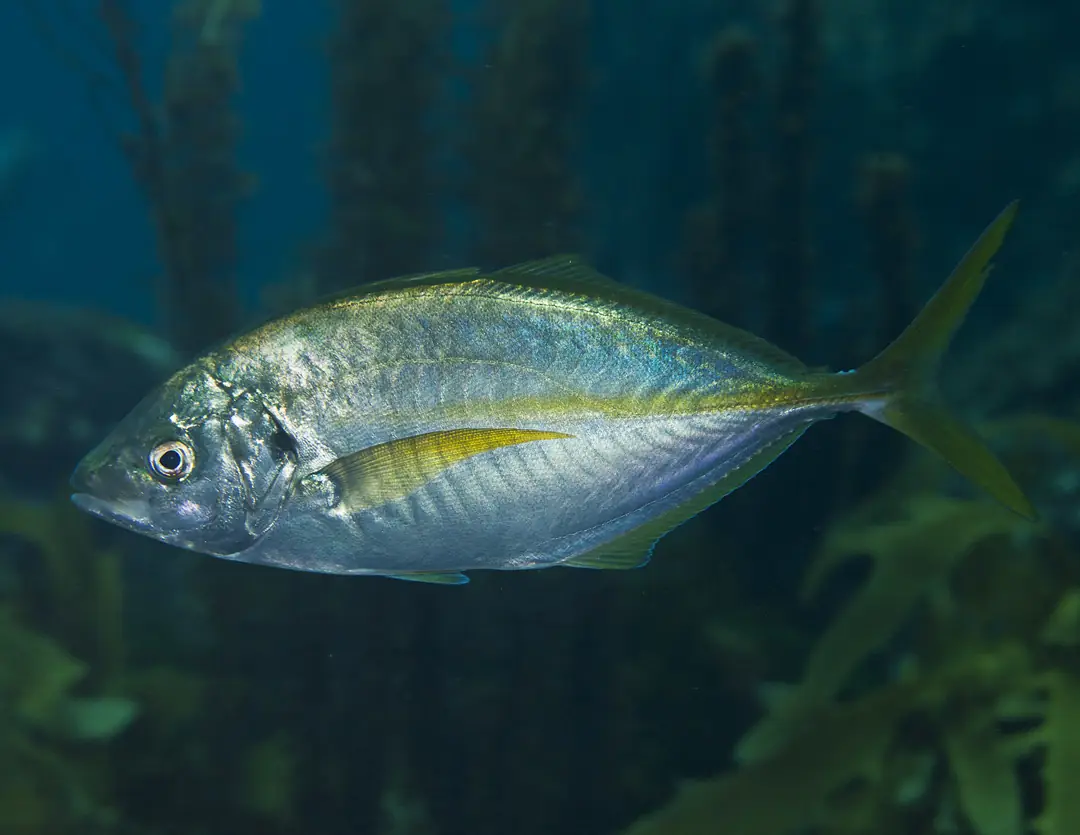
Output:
top-left (0, 500), bottom-right (138, 833)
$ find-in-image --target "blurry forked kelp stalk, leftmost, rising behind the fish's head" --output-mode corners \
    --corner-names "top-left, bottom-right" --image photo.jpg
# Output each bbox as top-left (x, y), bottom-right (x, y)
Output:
top-left (99, 0), bottom-right (259, 352)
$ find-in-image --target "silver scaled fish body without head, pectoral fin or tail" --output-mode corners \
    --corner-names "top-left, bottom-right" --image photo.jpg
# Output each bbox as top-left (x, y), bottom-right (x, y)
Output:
top-left (201, 280), bottom-right (820, 574)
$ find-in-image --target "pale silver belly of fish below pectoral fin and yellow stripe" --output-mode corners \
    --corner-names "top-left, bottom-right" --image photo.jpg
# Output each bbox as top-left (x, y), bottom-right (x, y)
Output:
top-left (247, 409), bottom-right (815, 574)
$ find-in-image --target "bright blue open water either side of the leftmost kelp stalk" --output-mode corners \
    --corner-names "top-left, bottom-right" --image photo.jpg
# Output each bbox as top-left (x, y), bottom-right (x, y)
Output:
top-left (0, 3), bottom-right (329, 324)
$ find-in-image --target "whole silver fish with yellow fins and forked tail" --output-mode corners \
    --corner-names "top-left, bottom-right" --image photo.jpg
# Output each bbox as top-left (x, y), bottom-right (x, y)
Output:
top-left (71, 202), bottom-right (1036, 584)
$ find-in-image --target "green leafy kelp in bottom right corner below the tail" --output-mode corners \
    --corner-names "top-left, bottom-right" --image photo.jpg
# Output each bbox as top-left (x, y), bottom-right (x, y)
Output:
top-left (625, 418), bottom-right (1080, 835)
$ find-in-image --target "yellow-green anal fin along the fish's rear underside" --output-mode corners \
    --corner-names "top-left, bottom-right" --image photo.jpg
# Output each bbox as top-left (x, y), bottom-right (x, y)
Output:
top-left (559, 427), bottom-right (806, 569)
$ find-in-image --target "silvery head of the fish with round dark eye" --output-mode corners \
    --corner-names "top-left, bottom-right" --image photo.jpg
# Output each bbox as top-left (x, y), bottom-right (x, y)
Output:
top-left (71, 366), bottom-right (296, 556)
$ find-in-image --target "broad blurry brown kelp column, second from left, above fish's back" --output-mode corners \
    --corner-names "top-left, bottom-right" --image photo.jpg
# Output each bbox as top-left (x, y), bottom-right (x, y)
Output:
top-left (316, 0), bottom-right (447, 293)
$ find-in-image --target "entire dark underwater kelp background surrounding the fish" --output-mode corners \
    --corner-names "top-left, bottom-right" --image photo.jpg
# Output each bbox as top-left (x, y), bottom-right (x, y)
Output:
top-left (0, 0), bottom-right (1080, 835)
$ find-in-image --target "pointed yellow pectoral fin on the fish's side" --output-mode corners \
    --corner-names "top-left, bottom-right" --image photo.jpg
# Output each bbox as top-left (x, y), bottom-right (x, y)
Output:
top-left (322, 429), bottom-right (571, 513)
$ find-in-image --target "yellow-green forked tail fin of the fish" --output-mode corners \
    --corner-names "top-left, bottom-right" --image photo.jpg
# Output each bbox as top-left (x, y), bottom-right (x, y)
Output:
top-left (834, 201), bottom-right (1037, 520)
